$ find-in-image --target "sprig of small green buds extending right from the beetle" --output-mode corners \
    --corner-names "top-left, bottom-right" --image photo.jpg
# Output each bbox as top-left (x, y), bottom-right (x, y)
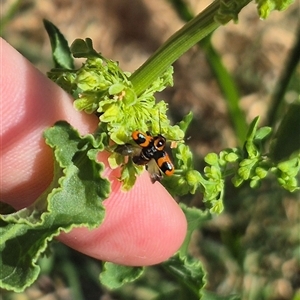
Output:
top-left (163, 117), bottom-right (300, 213)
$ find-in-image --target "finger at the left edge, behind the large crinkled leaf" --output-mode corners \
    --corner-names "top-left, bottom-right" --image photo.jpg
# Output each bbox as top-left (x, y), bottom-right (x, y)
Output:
top-left (0, 39), bottom-right (98, 209)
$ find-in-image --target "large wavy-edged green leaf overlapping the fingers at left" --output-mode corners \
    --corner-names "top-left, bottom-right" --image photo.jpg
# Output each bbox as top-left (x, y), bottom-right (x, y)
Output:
top-left (0, 122), bottom-right (110, 292)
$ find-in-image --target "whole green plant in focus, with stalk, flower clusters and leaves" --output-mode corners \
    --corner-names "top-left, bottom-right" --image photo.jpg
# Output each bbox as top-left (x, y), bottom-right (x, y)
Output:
top-left (1, 1), bottom-right (300, 299)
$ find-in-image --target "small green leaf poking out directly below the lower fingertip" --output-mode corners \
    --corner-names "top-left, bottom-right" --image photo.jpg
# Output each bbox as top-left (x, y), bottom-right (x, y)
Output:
top-left (100, 262), bottom-right (144, 289)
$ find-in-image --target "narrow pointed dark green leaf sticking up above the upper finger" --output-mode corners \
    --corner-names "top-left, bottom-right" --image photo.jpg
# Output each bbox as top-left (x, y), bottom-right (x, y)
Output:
top-left (43, 19), bottom-right (74, 70)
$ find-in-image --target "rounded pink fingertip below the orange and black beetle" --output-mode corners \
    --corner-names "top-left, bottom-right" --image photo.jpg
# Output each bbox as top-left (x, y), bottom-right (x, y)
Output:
top-left (59, 168), bottom-right (187, 266)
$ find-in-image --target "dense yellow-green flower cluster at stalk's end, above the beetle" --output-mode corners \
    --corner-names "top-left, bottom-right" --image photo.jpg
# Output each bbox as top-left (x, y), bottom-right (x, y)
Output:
top-left (49, 39), bottom-right (184, 190)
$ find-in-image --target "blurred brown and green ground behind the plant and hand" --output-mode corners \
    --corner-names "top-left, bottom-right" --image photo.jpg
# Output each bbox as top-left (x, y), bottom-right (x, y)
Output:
top-left (0, 0), bottom-right (300, 300)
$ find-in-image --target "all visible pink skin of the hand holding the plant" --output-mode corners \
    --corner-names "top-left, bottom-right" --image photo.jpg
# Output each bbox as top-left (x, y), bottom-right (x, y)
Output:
top-left (0, 39), bottom-right (187, 266)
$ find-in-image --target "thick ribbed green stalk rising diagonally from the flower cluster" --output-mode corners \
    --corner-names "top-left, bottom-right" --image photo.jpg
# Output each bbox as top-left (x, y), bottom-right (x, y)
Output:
top-left (130, 0), bottom-right (251, 95)
